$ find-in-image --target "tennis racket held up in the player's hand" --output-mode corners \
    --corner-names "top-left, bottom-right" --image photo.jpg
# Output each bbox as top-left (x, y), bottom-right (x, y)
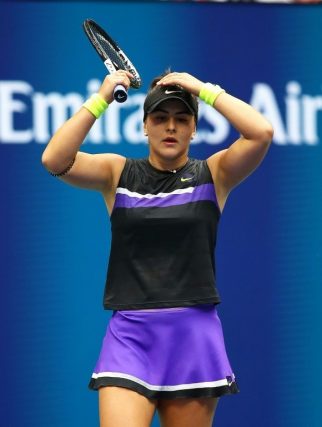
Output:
top-left (83, 19), bottom-right (141, 102)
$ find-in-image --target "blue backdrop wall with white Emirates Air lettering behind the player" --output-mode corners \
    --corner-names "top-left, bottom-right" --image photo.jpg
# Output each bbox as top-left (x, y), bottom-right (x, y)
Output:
top-left (0, 2), bottom-right (322, 427)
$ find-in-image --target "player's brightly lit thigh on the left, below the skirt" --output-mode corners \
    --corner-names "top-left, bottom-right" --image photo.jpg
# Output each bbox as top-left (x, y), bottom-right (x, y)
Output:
top-left (99, 386), bottom-right (157, 427)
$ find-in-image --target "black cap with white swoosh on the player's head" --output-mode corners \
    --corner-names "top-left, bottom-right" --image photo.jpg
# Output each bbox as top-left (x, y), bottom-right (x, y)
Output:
top-left (143, 85), bottom-right (198, 122)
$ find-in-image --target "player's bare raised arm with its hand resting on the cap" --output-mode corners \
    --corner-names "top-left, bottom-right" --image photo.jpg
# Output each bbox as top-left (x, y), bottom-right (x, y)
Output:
top-left (159, 73), bottom-right (273, 212)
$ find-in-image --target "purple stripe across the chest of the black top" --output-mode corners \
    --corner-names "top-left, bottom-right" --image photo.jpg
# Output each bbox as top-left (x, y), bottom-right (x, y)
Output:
top-left (114, 183), bottom-right (217, 208)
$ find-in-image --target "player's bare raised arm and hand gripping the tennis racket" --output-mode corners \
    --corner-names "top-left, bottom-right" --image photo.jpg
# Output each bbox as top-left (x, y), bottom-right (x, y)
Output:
top-left (42, 71), bottom-right (131, 192)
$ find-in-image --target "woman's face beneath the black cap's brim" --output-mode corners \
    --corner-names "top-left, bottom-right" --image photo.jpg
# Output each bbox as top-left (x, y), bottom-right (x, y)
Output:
top-left (144, 99), bottom-right (196, 160)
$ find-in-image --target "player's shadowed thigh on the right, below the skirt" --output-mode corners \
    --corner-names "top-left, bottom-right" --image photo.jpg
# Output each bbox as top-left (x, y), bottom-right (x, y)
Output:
top-left (157, 397), bottom-right (219, 427)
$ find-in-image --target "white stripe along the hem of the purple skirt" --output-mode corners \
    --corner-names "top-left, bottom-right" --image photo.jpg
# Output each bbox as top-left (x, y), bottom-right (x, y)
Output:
top-left (92, 372), bottom-right (234, 391)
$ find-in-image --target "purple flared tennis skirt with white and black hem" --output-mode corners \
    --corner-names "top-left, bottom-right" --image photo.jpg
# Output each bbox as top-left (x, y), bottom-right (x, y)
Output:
top-left (89, 305), bottom-right (238, 399)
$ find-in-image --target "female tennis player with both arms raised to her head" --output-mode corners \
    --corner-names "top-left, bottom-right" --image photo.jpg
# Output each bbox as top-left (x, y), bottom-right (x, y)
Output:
top-left (42, 71), bottom-right (273, 427)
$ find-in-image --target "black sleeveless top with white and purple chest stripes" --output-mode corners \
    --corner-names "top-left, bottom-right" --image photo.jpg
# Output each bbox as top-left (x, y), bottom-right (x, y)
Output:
top-left (104, 159), bottom-right (220, 310)
